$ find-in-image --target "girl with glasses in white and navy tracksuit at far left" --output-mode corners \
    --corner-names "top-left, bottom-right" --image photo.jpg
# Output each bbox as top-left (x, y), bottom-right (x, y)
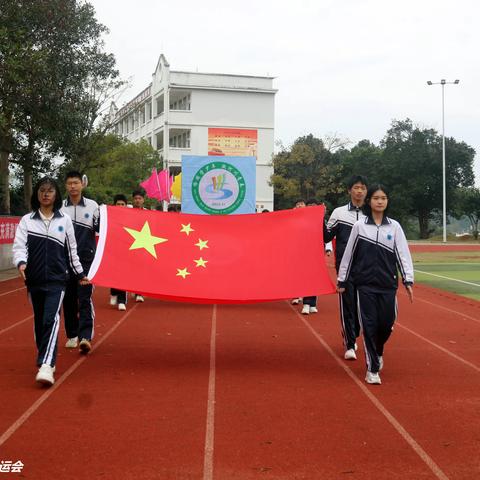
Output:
top-left (13, 178), bottom-right (88, 385)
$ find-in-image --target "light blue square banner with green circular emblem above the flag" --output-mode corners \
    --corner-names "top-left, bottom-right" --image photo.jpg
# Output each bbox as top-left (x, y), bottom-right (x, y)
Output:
top-left (182, 155), bottom-right (256, 215)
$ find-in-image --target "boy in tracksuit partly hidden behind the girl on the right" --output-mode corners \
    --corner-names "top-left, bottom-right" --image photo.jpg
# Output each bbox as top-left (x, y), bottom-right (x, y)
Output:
top-left (323, 175), bottom-right (367, 360)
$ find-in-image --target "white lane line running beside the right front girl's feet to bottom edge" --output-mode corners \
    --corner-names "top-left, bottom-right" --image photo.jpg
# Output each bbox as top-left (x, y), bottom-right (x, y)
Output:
top-left (288, 304), bottom-right (449, 480)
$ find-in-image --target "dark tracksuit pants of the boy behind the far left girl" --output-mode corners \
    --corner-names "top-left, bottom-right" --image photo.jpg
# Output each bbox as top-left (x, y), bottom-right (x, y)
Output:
top-left (63, 269), bottom-right (95, 340)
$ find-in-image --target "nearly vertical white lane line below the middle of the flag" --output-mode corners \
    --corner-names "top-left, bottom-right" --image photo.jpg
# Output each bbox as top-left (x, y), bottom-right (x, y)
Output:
top-left (203, 305), bottom-right (217, 480)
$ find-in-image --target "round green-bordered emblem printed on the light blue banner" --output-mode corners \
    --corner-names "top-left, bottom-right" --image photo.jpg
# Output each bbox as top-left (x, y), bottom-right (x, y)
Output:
top-left (192, 162), bottom-right (246, 214)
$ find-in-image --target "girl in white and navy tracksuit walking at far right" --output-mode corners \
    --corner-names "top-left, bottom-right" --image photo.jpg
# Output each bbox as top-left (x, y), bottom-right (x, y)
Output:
top-left (338, 184), bottom-right (413, 385)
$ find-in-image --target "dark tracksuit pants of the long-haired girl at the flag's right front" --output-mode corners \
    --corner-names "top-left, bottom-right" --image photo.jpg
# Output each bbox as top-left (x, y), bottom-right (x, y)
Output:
top-left (357, 287), bottom-right (397, 373)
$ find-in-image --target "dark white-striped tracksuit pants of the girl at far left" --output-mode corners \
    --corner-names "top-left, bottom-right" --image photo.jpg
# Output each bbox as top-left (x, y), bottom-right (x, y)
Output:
top-left (28, 287), bottom-right (65, 367)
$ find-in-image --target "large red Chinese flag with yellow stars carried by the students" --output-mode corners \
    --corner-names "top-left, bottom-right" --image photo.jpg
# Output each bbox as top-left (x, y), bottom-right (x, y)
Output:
top-left (88, 206), bottom-right (335, 303)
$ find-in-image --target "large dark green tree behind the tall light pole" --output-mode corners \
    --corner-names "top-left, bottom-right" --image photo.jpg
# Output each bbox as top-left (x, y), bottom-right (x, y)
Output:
top-left (377, 118), bottom-right (475, 238)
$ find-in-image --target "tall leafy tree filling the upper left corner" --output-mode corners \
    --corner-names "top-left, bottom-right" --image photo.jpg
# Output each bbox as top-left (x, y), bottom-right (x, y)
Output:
top-left (0, 0), bottom-right (118, 213)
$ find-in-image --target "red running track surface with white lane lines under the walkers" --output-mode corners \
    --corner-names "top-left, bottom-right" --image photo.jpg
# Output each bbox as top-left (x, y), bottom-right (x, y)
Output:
top-left (0, 270), bottom-right (480, 480)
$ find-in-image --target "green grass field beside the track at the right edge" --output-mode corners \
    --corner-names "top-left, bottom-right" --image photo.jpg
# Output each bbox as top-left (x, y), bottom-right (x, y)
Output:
top-left (412, 251), bottom-right (480, 301)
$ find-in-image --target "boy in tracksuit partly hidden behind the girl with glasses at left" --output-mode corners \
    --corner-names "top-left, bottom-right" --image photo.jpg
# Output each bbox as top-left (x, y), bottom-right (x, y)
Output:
top-left (62, 171), bottom-right (99, 354)
